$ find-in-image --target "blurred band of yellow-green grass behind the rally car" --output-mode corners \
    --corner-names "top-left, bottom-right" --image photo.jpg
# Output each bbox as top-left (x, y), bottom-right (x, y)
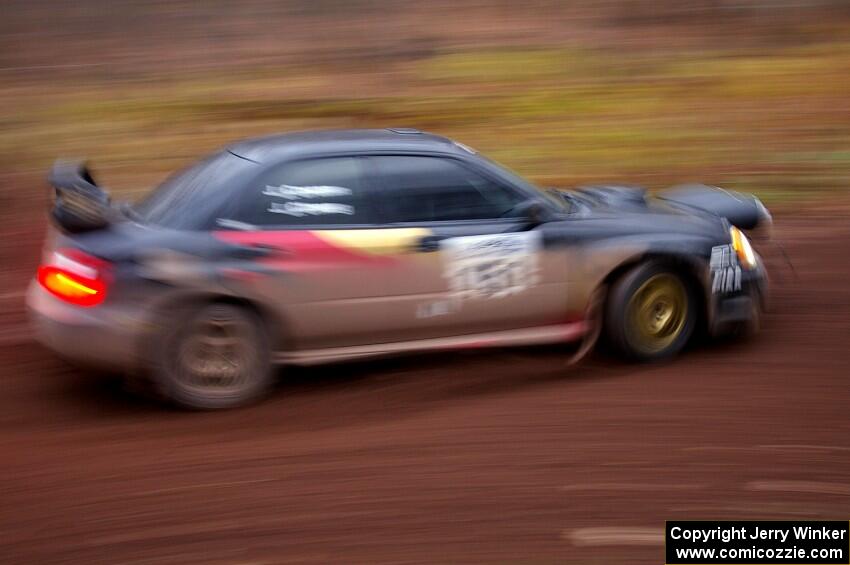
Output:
top-left (0, 42), bottom-right (850, 201)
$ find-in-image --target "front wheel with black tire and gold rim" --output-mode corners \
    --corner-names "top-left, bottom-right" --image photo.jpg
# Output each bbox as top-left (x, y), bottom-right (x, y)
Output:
top-left (604, 262), bottom-right (698, 362)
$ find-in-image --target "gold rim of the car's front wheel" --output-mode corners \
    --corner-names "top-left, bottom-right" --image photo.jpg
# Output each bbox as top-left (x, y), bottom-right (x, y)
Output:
top-left (627, 273), bottom-right (688, 353)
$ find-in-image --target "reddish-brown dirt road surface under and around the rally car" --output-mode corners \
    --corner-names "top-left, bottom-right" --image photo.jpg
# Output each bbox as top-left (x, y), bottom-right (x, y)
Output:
top-left (0, 200), bottom-right (850, 564)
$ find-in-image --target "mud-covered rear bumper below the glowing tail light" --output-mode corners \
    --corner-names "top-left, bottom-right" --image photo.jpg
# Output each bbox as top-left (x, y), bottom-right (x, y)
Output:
top-left (27, 281), bottom-right (144, 371)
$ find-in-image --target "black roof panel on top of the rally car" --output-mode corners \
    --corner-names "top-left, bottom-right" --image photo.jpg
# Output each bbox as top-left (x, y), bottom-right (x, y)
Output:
top-left (227, 128), bottom-right (463, 163)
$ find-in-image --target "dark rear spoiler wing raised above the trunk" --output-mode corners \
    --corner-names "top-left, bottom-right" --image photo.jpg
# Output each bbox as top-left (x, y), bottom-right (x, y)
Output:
top-left (47, 161), bottom-right (112, 233)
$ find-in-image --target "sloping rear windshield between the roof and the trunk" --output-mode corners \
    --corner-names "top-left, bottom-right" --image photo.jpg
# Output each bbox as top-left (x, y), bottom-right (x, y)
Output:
top-left (133, 151), bottom-right (257, 229)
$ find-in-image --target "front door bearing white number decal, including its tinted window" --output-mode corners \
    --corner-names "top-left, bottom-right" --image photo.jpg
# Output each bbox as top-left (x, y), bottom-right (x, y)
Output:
top-left (369, 155), bottom-right (567, 341)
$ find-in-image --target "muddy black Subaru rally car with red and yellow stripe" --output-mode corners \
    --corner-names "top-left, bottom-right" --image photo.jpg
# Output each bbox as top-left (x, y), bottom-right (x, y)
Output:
top-left (28, 128), bottom-right (770, 408)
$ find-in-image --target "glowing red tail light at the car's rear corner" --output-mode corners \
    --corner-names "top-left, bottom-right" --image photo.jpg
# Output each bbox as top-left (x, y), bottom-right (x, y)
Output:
top-left (38, 249), bottom-right (108, 307)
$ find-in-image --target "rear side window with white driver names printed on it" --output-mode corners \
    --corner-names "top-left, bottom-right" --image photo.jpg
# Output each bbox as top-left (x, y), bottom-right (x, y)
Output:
top-left (232, 157), bottom-right (371, 226)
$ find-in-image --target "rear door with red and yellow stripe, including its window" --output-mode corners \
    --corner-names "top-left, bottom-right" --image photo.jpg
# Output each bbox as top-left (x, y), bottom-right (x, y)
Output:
top-left (217, 156), bottom-right (426, 350)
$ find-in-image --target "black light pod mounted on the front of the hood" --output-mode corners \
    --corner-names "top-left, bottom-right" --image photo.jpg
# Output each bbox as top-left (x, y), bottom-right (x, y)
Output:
top-left (658, 184), bottom-right (773, 230)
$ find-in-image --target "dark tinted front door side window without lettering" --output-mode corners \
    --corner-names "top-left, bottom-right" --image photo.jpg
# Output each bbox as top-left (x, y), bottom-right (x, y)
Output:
top-left (370, 155), bottom-right (524, 223)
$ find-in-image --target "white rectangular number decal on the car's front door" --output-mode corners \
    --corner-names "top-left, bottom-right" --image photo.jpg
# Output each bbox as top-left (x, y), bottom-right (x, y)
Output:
top-left (440, 232), bottom-right (541, 300)
